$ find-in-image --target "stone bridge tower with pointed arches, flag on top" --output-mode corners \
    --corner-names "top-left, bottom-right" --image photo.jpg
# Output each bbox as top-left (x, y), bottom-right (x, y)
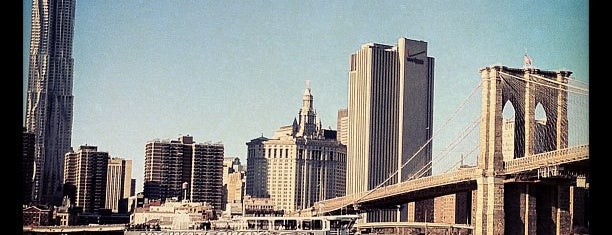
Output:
top-left (474, 66), bottom-right (571, 235)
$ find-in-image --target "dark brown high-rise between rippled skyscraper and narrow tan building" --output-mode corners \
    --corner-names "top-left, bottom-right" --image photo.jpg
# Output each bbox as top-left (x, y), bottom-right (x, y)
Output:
top-left (64, 145), bottom-right (109, 212)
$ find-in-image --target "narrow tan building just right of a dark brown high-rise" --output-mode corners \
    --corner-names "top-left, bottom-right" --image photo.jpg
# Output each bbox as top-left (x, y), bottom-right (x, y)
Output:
top-left (106, 157), bottom-right (132, 213)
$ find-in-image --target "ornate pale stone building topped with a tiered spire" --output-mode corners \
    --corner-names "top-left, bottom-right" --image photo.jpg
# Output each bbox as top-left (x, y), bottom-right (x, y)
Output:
top-left (246, 83), bottom-right (346, 213)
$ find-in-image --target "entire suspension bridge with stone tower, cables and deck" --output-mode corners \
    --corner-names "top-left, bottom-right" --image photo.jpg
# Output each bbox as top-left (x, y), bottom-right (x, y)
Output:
top-left (295, 66), bottom-right (589, 235)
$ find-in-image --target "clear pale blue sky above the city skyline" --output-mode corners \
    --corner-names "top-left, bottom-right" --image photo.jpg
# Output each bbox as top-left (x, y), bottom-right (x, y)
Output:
top-left (23, 0), bottom-right (589, 193)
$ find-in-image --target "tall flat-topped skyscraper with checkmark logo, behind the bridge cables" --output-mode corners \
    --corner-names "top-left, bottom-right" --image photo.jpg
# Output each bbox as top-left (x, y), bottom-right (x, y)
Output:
top-left (347, 38), bottom-right (434, 222)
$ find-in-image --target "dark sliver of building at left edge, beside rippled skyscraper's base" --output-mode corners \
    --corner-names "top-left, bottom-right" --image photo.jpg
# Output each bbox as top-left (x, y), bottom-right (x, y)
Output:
top-left (21, 127), bottom-right (35, 204)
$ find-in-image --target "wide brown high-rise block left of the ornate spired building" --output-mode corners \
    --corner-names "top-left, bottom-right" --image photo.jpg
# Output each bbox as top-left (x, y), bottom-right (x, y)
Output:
top-left (144, 136), bottom-right (224, 210)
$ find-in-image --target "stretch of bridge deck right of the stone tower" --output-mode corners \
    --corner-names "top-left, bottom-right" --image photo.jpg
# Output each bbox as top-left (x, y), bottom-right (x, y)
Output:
top-left (504, 144), bottom-right (589, 174)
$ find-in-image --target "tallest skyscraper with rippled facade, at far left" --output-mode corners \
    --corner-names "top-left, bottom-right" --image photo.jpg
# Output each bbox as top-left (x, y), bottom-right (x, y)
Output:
top-left (25, 0), bottom-right (76, 205)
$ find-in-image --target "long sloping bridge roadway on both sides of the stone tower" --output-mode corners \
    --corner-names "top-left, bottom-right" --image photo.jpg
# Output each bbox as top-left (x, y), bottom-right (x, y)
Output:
top-left (306, 144), bottom-right (589, 215)
